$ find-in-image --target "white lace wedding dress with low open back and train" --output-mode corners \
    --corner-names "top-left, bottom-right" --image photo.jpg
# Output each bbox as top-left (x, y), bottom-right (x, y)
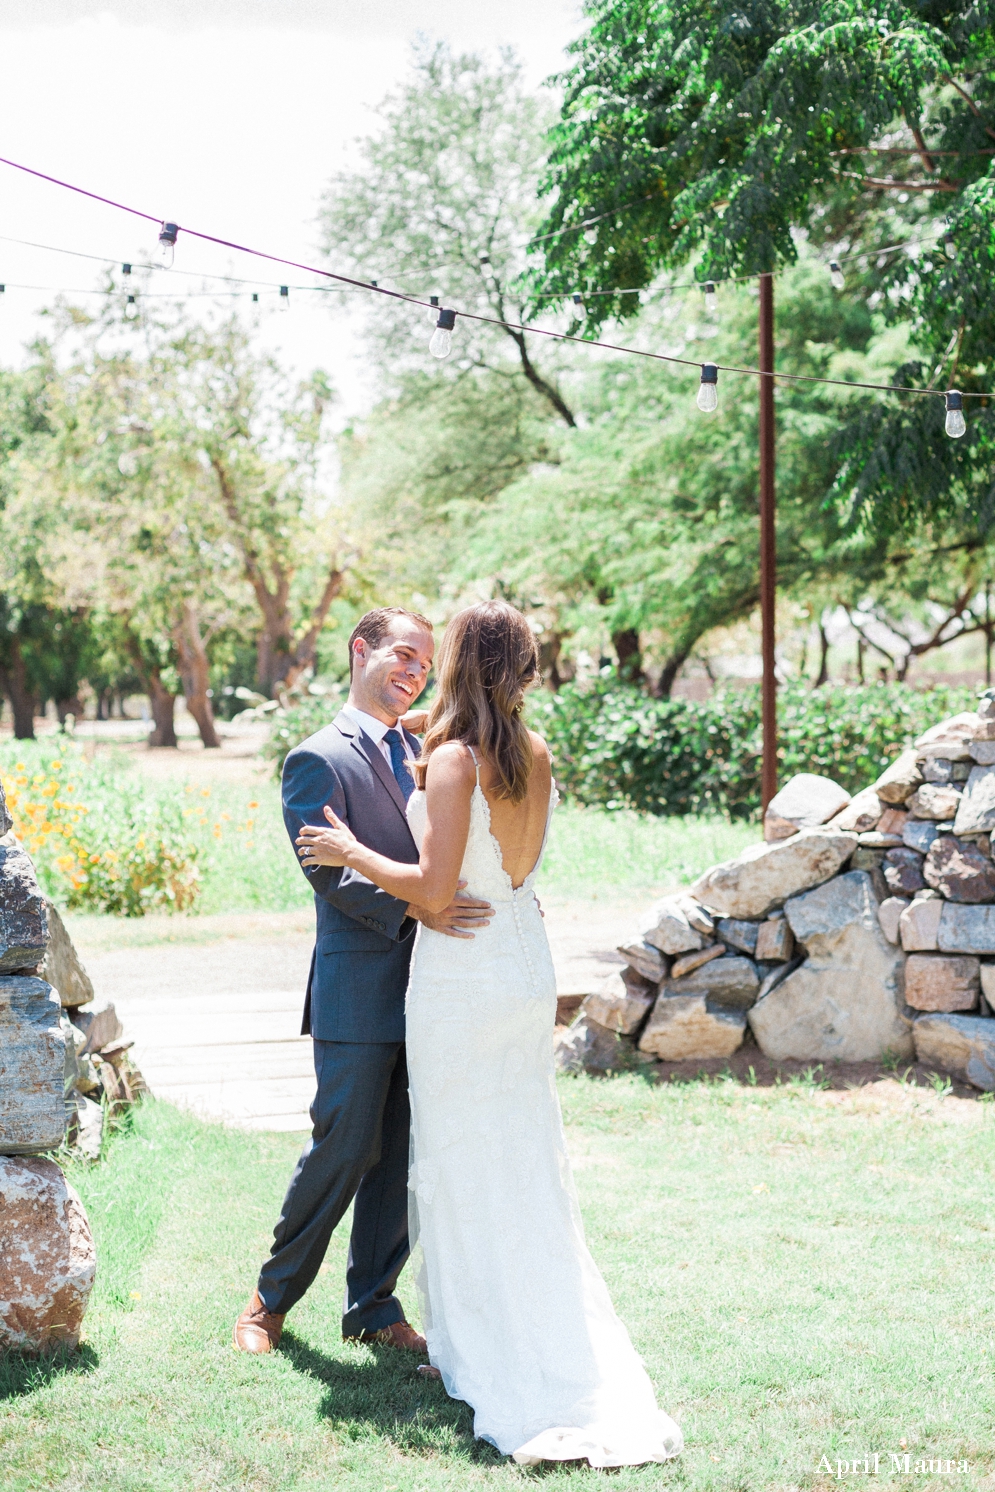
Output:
top-left (407, 767), bottom-right (683, 1467)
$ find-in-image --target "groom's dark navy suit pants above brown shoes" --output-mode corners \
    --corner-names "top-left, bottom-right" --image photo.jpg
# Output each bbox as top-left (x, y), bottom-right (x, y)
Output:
top-left (258, 1040), bottom-right (410, 1337)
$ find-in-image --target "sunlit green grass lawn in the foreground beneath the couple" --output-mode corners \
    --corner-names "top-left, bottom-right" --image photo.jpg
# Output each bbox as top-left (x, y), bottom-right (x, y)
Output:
top-left (0, 1076), bottom-right (995, 1492)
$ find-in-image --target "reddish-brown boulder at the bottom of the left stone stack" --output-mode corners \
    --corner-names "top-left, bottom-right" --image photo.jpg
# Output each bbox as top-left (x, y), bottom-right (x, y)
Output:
top-left (0, 1156), bottom-right (97, 1353)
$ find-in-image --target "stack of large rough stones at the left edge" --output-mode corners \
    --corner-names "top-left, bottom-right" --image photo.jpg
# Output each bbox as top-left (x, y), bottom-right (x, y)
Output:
top-left (0, 785), bottom-right (145, 1353)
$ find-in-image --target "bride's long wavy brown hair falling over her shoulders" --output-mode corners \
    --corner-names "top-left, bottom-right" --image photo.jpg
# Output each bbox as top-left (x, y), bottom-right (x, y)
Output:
top-left (415, 601), bottom-right (539, 803)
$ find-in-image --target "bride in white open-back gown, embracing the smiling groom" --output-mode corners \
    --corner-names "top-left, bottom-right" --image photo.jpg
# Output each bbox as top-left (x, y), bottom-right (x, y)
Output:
top-left (298, 601), bottom-right (683, 1467)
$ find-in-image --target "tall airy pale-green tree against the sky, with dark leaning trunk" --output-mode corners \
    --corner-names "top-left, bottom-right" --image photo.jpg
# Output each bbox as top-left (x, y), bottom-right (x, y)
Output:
top-left (321, 43), bottom-right (574, 425)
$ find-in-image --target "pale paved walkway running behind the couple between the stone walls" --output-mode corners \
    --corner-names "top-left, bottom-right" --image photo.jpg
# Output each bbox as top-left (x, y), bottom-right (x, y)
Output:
top-left (81, 900), bottom-right (627, 1129)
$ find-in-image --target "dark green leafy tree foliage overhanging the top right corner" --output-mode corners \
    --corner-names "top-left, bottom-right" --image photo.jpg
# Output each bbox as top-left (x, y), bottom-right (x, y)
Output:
top-left (542, 0), bottom-right (995, 546)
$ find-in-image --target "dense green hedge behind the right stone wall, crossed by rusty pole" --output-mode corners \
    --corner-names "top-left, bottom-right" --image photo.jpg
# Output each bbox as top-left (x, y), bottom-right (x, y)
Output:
top-left (530, 670), bottom-right (977, 819)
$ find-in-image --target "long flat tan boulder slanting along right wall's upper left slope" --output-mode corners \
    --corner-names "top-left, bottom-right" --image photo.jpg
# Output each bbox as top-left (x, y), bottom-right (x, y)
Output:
top-left (692, 828), bottom-right (856, 918)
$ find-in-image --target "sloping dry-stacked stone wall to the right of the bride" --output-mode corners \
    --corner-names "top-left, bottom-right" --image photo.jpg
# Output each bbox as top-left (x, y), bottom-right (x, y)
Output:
top-left (558, 689), bottom-right (995, 1091)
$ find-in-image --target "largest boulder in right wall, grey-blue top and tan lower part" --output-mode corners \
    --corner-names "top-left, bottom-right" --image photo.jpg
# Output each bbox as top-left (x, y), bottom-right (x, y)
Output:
top-left (747, 871), bottom-right (913, 1062)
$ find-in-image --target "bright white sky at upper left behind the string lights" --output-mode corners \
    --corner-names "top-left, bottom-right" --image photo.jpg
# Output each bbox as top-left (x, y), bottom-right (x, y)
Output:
top-left (0, 0), bottom-right (583, 416)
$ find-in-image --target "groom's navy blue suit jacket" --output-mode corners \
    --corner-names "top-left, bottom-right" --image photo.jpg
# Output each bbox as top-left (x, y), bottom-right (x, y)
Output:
top-left (283, 715), bottom-right (419, 1041)
